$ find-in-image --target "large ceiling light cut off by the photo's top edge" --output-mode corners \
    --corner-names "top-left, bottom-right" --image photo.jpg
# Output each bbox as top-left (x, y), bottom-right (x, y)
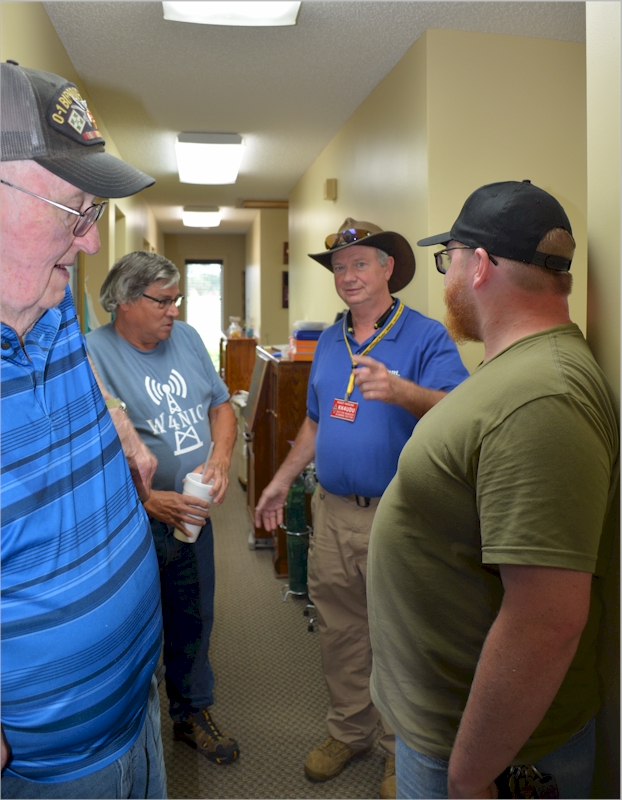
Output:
top-left (162, 0), bottom-right (300, 27)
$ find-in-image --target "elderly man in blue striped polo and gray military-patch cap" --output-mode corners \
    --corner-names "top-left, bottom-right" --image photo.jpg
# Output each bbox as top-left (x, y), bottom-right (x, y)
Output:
top-left (0, 62), bottom-right (166, 798)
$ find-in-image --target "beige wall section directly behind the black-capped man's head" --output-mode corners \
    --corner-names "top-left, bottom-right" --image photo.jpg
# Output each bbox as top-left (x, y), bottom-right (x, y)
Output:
top-left (426, 30), bottom-right (587, 370)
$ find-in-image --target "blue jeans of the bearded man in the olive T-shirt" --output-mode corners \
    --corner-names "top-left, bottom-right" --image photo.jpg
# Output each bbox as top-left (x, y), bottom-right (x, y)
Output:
top-left (395, 717), bottom-right (596, 799)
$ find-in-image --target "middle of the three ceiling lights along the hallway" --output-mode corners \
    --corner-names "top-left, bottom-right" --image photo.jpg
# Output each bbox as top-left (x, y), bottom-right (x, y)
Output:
top-left (175, 133), bottom-right (244, 184)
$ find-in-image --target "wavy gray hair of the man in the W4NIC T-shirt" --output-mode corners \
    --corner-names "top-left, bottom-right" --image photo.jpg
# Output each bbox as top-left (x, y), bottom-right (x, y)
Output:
top-left (99, 250), bottom-right (180, 312)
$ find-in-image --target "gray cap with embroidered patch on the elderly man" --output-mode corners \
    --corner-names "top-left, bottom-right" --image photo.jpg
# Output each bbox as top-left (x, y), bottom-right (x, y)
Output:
top-left (0, 61), bottom-right (155, 197)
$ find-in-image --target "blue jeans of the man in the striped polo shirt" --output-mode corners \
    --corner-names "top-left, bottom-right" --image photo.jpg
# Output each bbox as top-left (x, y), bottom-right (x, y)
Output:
top-left (2, 678), bottom-right (167, 800)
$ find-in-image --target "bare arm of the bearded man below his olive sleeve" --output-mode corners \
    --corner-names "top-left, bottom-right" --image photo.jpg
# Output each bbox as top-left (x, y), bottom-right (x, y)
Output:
top-left (448, 567), bottom-right (591, 797)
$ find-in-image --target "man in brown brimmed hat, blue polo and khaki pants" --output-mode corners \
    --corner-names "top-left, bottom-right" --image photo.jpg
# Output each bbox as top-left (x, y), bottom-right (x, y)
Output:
top-left (256, 218), bottom-right (468, 797)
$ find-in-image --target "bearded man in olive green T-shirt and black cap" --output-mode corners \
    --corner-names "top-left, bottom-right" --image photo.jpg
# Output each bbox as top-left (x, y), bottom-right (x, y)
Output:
top-left (368, 181), bottom-right (618, 798)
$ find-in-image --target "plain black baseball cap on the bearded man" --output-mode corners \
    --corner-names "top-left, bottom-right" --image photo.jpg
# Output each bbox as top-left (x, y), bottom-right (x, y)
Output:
top-left (417, 180), bottom-right (572, 272)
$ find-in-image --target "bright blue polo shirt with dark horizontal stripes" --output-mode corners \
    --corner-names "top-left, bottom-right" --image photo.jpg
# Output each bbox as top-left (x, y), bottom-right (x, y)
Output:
top-left (0, 290), bottom-right (161, 783)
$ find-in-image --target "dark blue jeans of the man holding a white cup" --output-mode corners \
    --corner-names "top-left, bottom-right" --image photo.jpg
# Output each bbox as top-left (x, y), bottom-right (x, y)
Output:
top-left (149, 517), bottom-right (215, 722)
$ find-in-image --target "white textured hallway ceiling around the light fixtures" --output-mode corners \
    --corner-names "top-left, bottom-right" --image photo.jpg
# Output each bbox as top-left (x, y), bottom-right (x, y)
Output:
top-left (42, 0), bottom-right (585, 233)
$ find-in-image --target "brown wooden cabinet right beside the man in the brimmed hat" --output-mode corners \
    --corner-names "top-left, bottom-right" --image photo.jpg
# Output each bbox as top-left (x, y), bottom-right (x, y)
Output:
top-left (245, 347), bottom-right (311, 578)
